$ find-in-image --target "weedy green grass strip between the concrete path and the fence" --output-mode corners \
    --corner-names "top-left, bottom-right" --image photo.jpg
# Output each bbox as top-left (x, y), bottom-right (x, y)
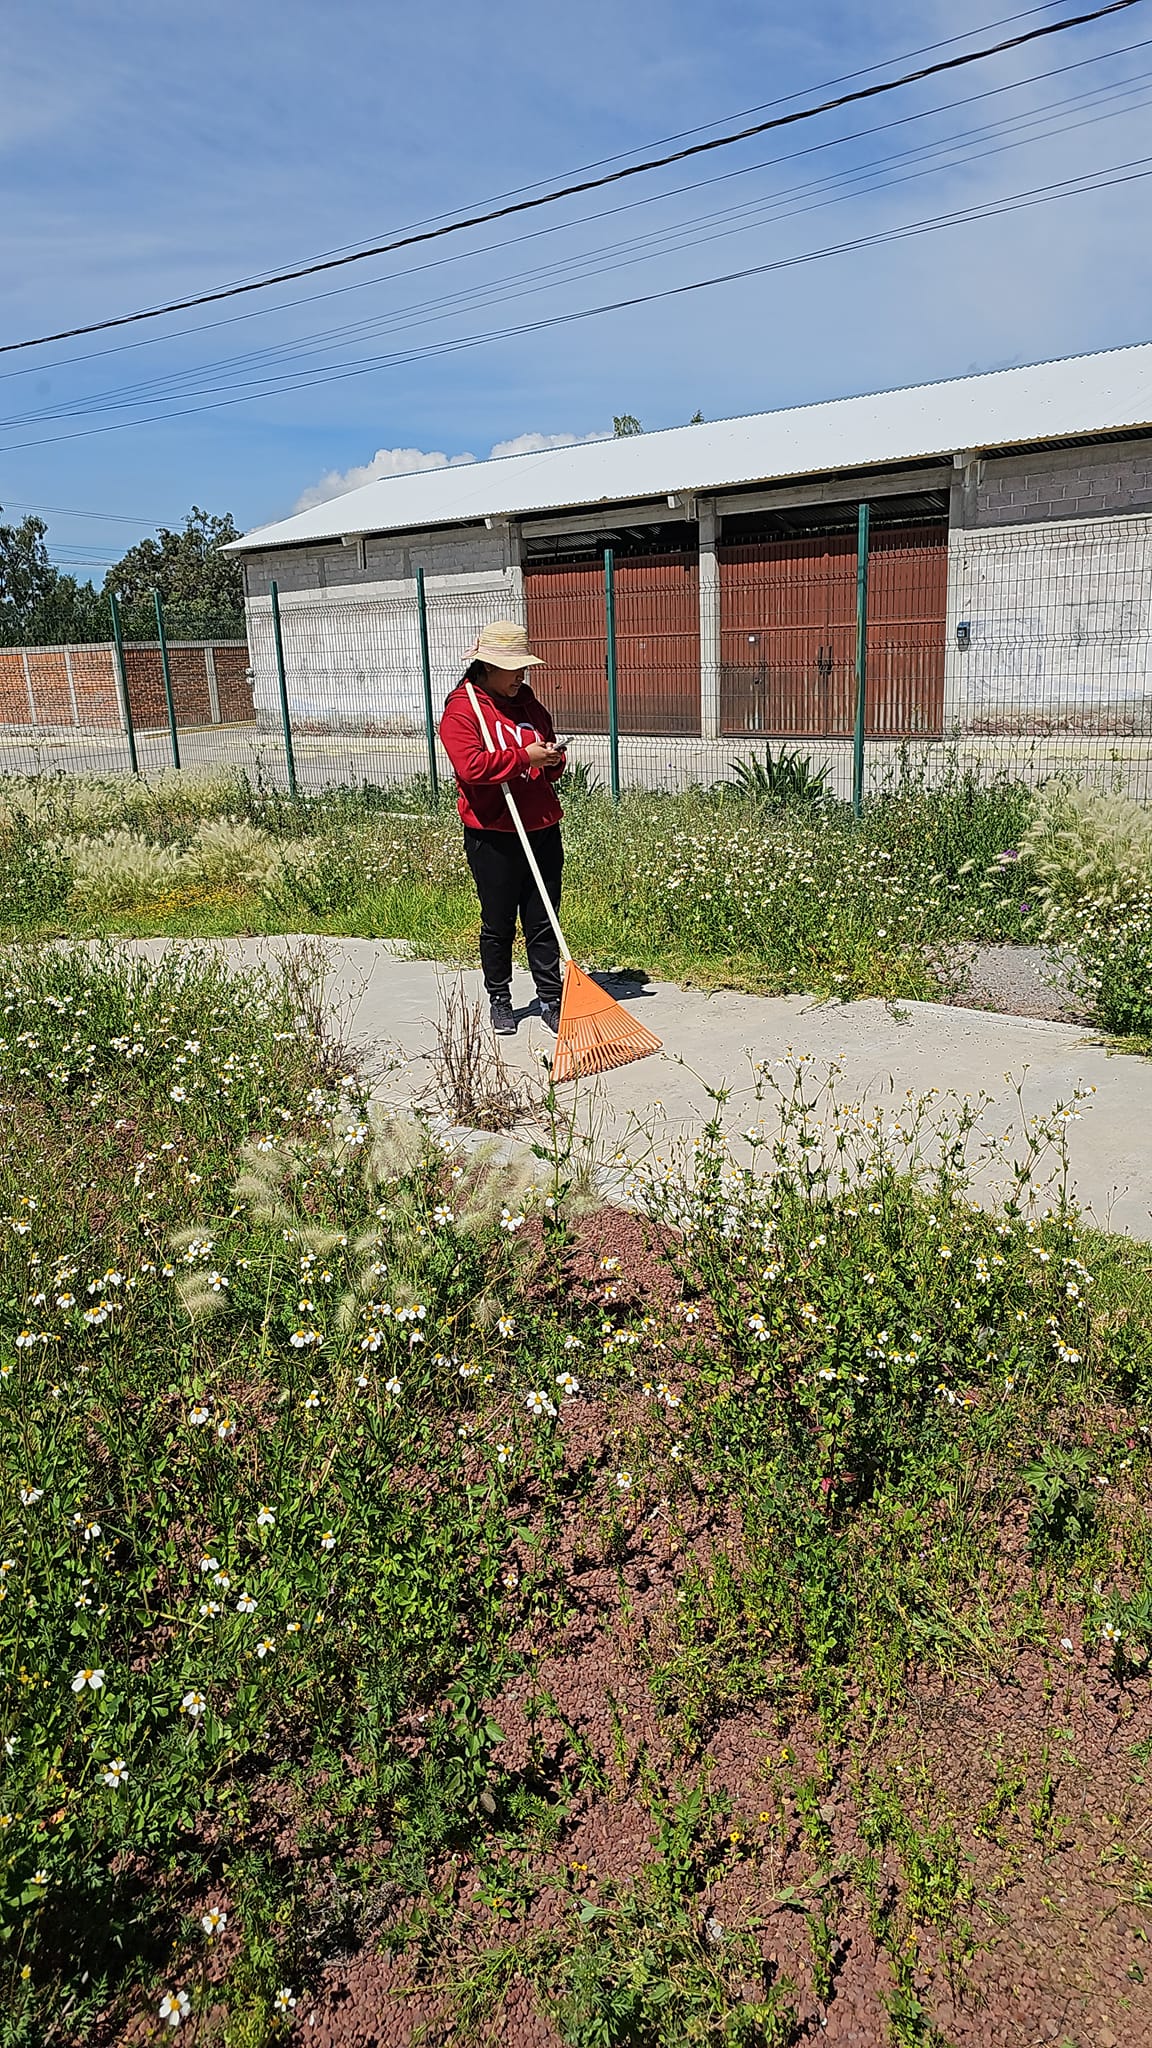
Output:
top-left (0, 774), bottom-right (1031, 997)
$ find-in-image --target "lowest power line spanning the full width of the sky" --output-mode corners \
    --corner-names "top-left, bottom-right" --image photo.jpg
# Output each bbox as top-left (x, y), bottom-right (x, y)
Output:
top-left (4, 156), bottom-right (1152, 453)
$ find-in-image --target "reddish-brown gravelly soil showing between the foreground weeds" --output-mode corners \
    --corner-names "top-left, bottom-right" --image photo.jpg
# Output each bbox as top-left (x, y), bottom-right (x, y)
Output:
top-left (119, 1210), bottom-right (1152, 2048)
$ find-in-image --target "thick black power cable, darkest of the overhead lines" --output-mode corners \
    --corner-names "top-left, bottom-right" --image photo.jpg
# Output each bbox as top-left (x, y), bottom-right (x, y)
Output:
top-left (0, 0), bottom-right (1140, 354)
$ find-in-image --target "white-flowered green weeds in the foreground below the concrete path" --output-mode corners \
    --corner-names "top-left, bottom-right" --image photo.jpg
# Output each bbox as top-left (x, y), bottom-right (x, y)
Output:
top-left (0, 948), bottom-right (1152, 2048)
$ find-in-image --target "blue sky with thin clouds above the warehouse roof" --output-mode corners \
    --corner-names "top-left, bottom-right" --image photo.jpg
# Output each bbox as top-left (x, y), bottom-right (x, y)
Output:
top-left (0, 0), bottom-right (1152, 578)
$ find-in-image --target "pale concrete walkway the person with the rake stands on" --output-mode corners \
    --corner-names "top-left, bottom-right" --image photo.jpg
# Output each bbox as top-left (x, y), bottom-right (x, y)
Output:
top-left (118, 938), bottom-right (1152, 1237)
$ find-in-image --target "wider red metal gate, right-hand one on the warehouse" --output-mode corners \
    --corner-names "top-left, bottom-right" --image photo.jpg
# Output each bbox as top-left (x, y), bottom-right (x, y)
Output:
top-left (717, 522), bottom-right (947, 737)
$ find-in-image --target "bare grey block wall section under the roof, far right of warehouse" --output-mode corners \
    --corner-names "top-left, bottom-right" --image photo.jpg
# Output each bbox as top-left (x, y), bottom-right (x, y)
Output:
top-left (953, 438), bottom-right (1152, 528)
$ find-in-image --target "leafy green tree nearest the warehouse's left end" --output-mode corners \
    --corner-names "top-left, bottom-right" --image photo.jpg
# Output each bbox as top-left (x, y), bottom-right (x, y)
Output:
top-left (105, 506), bottom-right (244, 637)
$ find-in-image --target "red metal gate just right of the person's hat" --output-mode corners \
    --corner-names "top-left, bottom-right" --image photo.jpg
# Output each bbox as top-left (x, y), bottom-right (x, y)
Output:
top-left (525, 553), bottom-right (701, 733)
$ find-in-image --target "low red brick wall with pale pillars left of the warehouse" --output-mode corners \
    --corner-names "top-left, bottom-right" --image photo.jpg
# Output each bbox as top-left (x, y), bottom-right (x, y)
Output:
top-left (0, 641), bottom-right (254, 731)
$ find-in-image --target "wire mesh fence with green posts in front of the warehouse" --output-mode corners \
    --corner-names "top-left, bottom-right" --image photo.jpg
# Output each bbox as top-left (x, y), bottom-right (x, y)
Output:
top-left (0, 509), bottom-right (1152, 801)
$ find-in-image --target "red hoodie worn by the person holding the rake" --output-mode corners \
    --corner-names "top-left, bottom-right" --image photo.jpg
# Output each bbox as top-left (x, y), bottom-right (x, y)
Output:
top-left (441, 682), bottom-right (564, 831)
